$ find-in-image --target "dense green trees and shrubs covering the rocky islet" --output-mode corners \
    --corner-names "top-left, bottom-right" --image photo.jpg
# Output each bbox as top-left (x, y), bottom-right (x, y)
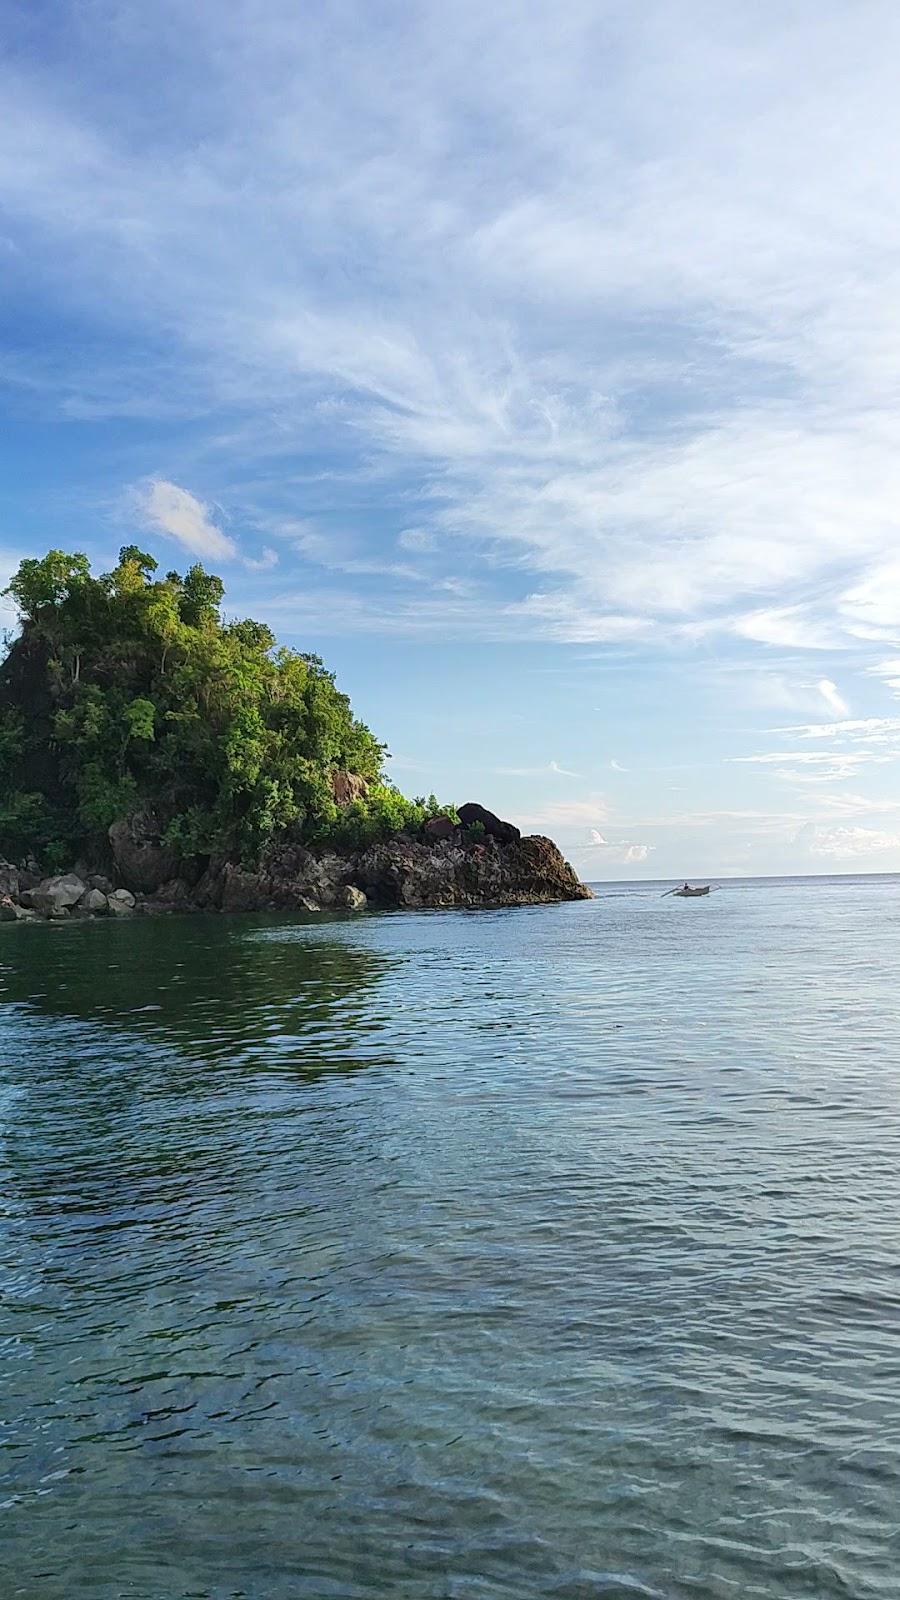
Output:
top-left (0, 546), bottom-right (437, 866)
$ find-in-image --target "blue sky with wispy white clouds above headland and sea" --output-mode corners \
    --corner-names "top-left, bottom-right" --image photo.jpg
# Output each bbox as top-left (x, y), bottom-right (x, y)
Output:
top-left (0, 0), bottom-right (900, 880)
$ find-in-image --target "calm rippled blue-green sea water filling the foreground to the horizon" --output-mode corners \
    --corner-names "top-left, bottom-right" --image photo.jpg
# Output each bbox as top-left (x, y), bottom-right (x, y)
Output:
top-left (0, 878), bottom-right (900, 1600)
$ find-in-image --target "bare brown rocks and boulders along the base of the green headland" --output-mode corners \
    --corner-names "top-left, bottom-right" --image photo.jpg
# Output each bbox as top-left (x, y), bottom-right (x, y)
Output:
top-left (0, 805), bottom-right (591, 922)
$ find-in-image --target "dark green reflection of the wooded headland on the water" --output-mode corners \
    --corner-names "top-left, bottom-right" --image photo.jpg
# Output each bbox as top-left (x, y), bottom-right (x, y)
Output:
top-left (0, 917), bottom-right (389, 1070)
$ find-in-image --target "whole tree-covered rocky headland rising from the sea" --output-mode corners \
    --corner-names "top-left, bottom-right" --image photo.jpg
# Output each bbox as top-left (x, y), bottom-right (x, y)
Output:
top-left (0, 544), bottom-right (591, 922)
